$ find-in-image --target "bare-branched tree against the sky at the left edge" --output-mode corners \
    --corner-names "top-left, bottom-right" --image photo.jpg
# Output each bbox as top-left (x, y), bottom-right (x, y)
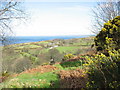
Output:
top-left (0, 0), bottom-right (25, 45)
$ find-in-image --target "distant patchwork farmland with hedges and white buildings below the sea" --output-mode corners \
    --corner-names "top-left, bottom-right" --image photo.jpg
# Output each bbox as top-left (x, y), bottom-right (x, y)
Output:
top-left (2, 37), bottom-right (93, 72)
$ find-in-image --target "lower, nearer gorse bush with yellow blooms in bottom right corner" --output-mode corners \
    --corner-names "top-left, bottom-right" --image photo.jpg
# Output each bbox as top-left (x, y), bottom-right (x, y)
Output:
top-left (84, 50), bottom-right (120, 88)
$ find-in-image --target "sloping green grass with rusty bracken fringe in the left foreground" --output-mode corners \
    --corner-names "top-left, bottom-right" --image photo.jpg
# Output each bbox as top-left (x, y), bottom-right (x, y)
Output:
top-left (0, 61), bottom-right (82, 88)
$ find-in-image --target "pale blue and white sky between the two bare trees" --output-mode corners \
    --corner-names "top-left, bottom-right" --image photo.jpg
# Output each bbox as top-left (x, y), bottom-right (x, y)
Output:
top-left (14, 0), bottom-right (95, 36)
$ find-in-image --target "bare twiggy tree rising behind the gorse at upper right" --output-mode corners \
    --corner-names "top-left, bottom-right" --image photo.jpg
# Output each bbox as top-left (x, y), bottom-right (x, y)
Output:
top-left (92, 0), bottom-right (120, 34)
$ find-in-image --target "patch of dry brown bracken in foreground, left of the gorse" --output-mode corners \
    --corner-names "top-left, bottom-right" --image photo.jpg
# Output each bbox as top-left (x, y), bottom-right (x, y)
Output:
top-left (59, 69), bottom-right (87, 88)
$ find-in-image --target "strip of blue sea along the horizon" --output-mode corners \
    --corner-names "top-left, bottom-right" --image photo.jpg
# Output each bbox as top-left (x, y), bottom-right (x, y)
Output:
top-left (1, 35), bottom-right (93, 44)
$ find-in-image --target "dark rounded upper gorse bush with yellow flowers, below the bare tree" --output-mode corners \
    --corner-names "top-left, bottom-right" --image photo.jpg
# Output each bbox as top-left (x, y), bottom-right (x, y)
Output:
top-left (94, 16), bottom-right (120, 51)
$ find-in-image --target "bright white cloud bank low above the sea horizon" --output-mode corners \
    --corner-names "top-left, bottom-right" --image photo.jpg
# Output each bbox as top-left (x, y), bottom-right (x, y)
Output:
top-left (13, 11), bottom-right (90, 36)
